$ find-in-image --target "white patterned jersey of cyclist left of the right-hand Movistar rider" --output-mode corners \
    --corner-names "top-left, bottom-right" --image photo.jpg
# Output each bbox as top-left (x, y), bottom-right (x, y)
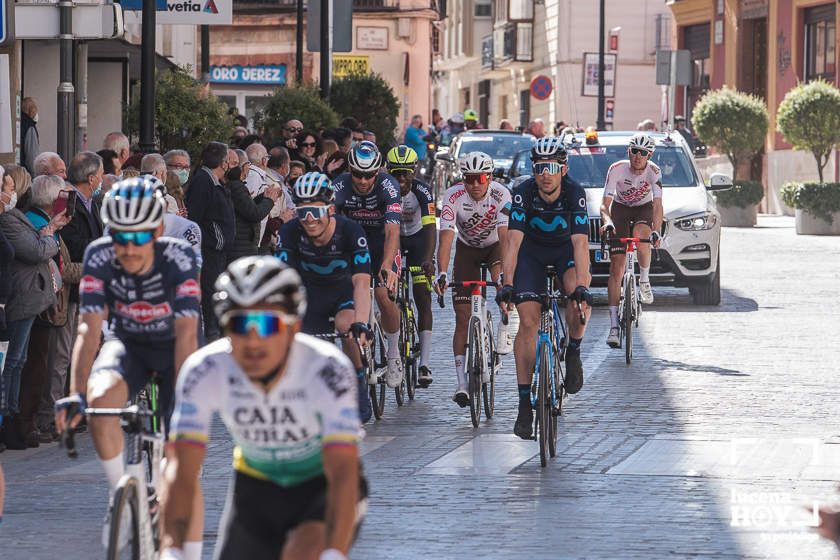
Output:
top-left (440, 181), bottom-right (511, 248)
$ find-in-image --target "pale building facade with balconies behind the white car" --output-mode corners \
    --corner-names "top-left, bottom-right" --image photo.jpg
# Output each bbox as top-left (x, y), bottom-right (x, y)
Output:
top-left (433, 0), bottom-right (671, 129)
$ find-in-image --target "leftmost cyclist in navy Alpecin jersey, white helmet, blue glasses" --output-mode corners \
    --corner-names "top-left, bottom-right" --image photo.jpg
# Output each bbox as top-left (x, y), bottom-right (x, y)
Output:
top-left (56, 177), bottom-right (203, 560)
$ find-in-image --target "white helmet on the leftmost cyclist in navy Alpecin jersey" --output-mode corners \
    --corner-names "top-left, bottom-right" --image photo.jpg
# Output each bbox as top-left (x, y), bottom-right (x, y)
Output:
top-left (100, 175), bottom-right (166, 231)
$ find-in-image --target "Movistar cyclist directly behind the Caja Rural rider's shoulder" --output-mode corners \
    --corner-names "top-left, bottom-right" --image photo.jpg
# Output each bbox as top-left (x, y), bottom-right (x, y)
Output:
top-left (277, 172), bottom-right (373, 422)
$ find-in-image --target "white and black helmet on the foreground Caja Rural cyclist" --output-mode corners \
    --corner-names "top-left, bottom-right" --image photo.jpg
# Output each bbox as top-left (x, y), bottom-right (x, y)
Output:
top-left (213, 255), bottom-right (306, 321)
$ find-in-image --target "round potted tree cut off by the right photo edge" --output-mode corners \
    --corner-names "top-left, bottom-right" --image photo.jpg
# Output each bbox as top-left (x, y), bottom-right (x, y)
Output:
top-left (778, 80), bottom-right (840, 183)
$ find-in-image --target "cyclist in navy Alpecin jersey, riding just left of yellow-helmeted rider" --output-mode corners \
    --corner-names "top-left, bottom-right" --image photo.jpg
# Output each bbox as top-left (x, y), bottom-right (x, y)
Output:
top-left (333, 141), bottom-right (403, 387)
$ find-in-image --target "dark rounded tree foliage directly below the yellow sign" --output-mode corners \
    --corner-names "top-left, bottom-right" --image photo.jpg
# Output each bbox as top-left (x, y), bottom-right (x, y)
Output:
top-left (330, 74), bottom-right (400, 150)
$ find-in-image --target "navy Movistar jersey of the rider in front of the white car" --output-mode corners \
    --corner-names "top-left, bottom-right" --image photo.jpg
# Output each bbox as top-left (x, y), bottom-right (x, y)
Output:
top-left (509, 177), bottom-right (589, 246)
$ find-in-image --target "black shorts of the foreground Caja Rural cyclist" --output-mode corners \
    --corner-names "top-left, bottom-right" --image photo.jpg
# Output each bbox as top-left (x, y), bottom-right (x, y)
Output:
top-left (215, 471), bottom-right (367, 560)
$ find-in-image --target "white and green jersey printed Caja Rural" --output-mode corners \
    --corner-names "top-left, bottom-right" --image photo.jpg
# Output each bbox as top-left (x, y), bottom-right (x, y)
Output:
top-left (170, 333), bottom-right (361, 487)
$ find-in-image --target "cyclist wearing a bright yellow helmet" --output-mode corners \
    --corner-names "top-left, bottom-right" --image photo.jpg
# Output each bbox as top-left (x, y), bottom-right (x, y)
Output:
top-left (385, 145), bottom-right (437, 387)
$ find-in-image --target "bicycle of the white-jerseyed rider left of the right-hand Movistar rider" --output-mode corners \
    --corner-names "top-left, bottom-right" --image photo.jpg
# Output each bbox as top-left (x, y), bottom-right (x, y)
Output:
top-left (438, 264), bottom-right (501, 428)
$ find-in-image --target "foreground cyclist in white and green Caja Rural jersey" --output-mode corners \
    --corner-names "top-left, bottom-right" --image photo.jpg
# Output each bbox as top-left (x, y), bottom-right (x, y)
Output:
top-left (162, 256), bottom-right (367, 560)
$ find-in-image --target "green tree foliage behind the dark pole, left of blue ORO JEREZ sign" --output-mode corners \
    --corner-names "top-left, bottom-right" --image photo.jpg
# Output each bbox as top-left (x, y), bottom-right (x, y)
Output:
top-left (124, 68), bottom-right (233, 160)
